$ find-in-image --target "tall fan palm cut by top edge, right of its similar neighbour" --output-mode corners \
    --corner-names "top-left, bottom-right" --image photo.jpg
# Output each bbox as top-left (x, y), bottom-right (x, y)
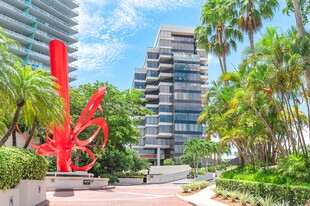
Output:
top-left (227, 0), bottom-right (279, 49)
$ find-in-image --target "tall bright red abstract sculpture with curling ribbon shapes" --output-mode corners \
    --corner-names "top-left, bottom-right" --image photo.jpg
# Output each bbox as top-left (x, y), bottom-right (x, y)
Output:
top-left (18, 40), bottom-right (109, 172)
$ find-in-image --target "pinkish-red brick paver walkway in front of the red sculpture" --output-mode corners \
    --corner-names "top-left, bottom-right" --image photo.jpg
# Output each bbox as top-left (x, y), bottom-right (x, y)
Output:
top-left (47, 184), bottom-right (190, 206)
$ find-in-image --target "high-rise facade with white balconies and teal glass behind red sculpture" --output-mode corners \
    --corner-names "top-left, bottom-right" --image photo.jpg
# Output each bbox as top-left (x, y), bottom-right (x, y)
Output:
top-left (0, 0), bottom-right (79, 81)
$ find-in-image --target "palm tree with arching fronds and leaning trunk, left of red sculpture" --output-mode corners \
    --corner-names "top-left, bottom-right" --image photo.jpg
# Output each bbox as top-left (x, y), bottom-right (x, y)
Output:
top-left (0, 66), bottom-right (64, 147)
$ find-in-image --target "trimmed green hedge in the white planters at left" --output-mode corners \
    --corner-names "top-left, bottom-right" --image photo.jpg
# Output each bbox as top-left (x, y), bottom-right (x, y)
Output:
top-left (0, 147), bottom-right (48, 190)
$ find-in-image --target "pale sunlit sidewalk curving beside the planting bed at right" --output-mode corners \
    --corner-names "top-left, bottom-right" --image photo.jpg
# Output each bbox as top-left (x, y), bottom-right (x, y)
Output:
top-left (176, 185), bottom-right (227, 206)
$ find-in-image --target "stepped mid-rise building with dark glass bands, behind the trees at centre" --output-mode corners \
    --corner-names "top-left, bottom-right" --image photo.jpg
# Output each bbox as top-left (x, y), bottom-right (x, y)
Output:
top-left (133, 25), bottom-right (208, 165)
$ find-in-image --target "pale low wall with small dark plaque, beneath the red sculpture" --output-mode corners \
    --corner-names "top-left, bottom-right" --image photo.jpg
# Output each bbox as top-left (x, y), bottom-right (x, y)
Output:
top-left (45, 176), bottom-right (109, 189)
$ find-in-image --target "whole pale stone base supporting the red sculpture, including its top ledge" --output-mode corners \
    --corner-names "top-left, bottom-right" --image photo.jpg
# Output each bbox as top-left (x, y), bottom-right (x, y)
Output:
top-left (45, 172), bottom-right (109, 190)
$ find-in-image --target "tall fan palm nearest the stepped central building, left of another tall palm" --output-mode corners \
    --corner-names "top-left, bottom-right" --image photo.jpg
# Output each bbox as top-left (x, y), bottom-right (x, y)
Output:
top-left (195, 0), bottom-right (243, 76)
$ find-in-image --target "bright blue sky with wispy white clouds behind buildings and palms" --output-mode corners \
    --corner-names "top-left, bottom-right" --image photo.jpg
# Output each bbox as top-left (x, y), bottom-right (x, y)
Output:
top-left (71, 0), bottom-right (302, 90)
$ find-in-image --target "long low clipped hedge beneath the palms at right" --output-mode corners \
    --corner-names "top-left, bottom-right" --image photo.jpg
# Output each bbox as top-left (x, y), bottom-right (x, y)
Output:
top-left (215, 178), bottom-right (310, 206)
